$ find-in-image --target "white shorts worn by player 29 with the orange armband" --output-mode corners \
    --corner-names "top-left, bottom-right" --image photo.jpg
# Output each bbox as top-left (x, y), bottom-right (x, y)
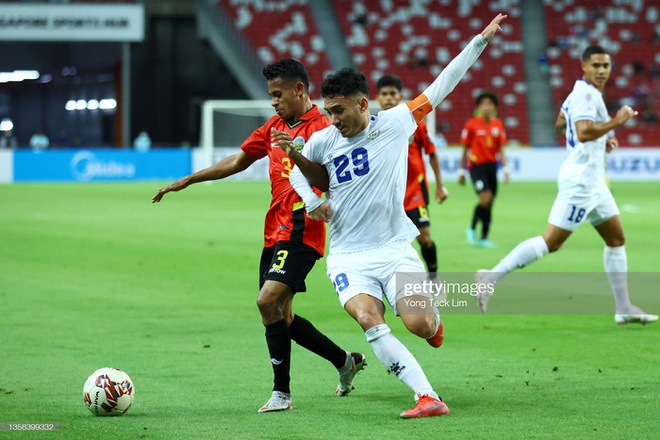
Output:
top-left (326, 241), bottom-right (426, 315)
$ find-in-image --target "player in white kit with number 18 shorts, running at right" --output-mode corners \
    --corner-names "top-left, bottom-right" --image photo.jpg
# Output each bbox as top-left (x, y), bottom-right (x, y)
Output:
top-left (477, 46), bottom-right (658, 324)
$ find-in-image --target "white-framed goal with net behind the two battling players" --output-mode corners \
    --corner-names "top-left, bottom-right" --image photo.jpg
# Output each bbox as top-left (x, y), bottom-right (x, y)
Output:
top-left (200, 100), bottom-right (435, 179)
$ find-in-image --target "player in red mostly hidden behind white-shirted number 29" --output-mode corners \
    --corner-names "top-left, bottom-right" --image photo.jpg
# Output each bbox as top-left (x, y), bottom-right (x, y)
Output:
top-left (376, 75), bottom-right (449, 274)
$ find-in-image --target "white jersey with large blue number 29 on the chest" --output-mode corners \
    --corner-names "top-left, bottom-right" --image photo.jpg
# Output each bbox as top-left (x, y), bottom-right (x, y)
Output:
top-left (302, 104), bottom-right (419, 253)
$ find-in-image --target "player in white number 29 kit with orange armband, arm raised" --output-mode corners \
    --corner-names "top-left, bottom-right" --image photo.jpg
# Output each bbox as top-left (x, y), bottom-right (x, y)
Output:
top-left (273, 14), bottom-right (506, 418)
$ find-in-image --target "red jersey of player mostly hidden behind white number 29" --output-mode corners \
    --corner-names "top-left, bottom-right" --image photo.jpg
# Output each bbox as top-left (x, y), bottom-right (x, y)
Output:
top-left (403, 121), bottom-right (435, 211)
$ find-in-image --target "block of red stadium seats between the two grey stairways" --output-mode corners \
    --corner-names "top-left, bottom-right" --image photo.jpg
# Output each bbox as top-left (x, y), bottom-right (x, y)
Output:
top-left (333, 0), bottom-right (529, 144)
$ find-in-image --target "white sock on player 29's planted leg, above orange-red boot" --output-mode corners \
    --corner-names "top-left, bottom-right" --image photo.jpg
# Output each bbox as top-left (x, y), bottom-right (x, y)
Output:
top-left (364, 324), bottom-right (438, 399)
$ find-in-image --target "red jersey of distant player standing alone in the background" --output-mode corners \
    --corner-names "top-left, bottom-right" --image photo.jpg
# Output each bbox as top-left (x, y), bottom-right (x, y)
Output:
top-left (461, 116), bottom-right (506, 169)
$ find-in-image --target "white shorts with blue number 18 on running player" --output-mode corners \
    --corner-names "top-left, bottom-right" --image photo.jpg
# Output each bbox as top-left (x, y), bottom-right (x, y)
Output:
top-left (548, 181), bottom-right (619, 231)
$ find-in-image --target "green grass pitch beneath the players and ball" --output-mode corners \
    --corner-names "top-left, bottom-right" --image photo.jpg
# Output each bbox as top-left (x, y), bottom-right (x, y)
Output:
top-left (0, 182), bottom-right (660, 439)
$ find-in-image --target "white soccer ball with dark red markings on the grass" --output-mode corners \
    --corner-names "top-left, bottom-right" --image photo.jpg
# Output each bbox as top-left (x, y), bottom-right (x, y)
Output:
top-left (83, 368), bottom-right (135, 416)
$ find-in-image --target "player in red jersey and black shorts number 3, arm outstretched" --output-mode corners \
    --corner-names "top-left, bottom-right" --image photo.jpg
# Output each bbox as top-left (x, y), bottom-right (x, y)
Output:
top-left (152, 59), bottom-right (365, 412)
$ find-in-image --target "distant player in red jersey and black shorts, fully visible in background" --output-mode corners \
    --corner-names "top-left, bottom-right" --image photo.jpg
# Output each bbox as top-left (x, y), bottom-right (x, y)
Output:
top-left (458, 92), bottom-right (509, 248)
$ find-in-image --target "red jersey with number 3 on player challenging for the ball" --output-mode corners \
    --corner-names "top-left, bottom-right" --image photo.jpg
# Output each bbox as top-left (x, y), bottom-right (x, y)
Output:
top-left (241, 105), bottom-right (330, 255)
